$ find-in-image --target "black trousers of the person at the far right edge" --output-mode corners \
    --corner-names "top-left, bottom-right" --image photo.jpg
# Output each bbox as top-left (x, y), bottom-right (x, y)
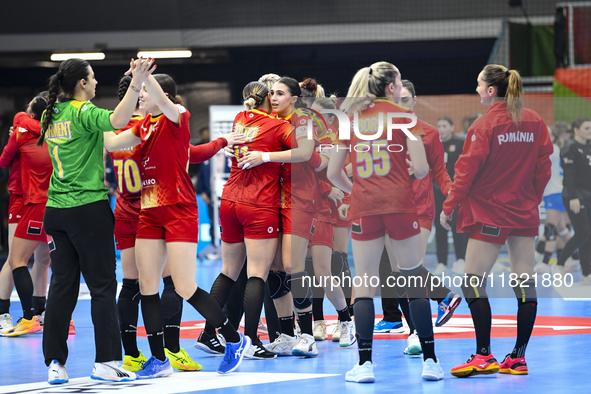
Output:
top-left (556, 199), bottom-right (591, 275)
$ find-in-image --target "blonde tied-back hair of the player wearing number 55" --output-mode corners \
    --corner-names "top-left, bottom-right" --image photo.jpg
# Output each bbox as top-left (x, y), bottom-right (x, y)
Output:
top-left (341, 61), bottom-right (400, 113)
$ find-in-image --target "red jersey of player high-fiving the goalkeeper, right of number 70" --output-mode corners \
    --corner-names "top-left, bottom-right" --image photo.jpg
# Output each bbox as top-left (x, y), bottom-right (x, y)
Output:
top-left (132, 105), bottom-right (197, 209)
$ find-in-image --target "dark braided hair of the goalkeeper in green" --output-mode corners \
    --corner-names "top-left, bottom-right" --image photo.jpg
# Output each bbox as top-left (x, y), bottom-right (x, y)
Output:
top-left (37, 58), bottom-right (90, 146)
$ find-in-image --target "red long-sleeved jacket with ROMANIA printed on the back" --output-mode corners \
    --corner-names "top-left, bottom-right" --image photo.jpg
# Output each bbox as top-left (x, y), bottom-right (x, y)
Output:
top-left (443, 101), bottom-right (554, 230)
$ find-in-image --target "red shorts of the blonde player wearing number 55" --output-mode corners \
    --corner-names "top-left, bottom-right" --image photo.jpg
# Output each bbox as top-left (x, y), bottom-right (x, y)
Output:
top-left (351, 212), bottom-right (421, 241)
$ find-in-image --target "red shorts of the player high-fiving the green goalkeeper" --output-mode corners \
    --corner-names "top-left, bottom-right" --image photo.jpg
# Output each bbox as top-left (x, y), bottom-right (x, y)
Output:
top-left (136, 204), bottom-right (199, 243)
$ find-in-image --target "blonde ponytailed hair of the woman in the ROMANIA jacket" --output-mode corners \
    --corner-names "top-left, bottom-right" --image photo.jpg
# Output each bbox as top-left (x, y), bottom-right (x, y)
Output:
top-left (482, 64), bottom-right (523, 124)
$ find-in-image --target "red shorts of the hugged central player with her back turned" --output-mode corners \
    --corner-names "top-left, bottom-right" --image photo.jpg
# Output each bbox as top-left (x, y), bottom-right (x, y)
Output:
top-left (220, 200), bottom-right (279, 243)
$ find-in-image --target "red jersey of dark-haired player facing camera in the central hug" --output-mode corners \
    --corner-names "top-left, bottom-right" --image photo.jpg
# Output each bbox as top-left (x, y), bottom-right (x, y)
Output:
top-left (281, 108), bottom-right (322, 212)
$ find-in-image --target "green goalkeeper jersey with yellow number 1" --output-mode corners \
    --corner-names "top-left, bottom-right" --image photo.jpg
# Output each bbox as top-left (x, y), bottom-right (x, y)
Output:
top-left (41, 100), bottom-right (114, 208)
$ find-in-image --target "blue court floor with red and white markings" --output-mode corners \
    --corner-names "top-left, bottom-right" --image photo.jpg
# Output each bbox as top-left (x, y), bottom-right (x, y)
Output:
top-left (0, 256), bottom-right (591, 394)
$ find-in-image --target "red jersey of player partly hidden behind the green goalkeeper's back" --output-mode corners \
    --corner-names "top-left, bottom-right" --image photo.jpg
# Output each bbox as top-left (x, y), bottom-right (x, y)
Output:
top-left (12, 112), bottom-right (53, 204)
